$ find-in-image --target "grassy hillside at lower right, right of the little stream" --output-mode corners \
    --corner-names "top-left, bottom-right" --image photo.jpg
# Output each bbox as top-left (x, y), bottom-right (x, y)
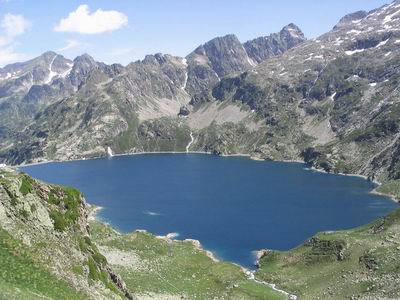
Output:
top-left (256, 210), bottom-right (400, 299)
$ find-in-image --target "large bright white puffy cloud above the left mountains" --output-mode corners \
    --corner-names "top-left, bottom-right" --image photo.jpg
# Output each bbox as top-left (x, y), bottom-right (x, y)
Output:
top-left (54, 4), bottom-right (128, 34)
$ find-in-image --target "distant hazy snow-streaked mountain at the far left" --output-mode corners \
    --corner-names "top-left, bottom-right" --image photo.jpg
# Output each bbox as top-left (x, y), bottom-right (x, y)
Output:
top-left (0, 52), bottom-right (72, 136)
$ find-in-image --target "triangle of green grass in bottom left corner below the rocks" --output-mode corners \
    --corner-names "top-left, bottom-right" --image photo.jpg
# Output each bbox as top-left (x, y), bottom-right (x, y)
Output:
top-left (0, 229), bottom-right (87, 299)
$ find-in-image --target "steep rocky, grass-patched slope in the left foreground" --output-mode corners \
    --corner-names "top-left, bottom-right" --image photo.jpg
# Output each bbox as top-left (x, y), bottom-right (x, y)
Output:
top-left (0, 168), bottom-right (131, 299)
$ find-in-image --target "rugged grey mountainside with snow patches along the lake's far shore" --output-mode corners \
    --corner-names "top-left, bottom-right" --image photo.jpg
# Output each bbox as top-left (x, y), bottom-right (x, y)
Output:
top-left (0, 1), bottom-right (400, 184)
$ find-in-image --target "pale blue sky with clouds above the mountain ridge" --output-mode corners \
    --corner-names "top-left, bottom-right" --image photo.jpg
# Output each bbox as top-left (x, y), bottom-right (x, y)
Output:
top-left (0, 0), bottom-right (391, 66)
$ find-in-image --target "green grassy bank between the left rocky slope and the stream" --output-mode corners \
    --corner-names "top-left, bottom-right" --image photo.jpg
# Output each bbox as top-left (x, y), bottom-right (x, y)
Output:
top-left (91, 222), bottom-right (285, 299)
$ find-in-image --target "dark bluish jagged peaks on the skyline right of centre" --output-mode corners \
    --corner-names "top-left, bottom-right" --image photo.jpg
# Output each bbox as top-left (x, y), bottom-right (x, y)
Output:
top-left (187, 24), bottom-right (305, 105)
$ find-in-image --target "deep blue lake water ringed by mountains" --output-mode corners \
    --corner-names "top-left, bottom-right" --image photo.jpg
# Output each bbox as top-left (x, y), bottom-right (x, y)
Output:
top-left (21, 154), bottom-right (398, 267)
